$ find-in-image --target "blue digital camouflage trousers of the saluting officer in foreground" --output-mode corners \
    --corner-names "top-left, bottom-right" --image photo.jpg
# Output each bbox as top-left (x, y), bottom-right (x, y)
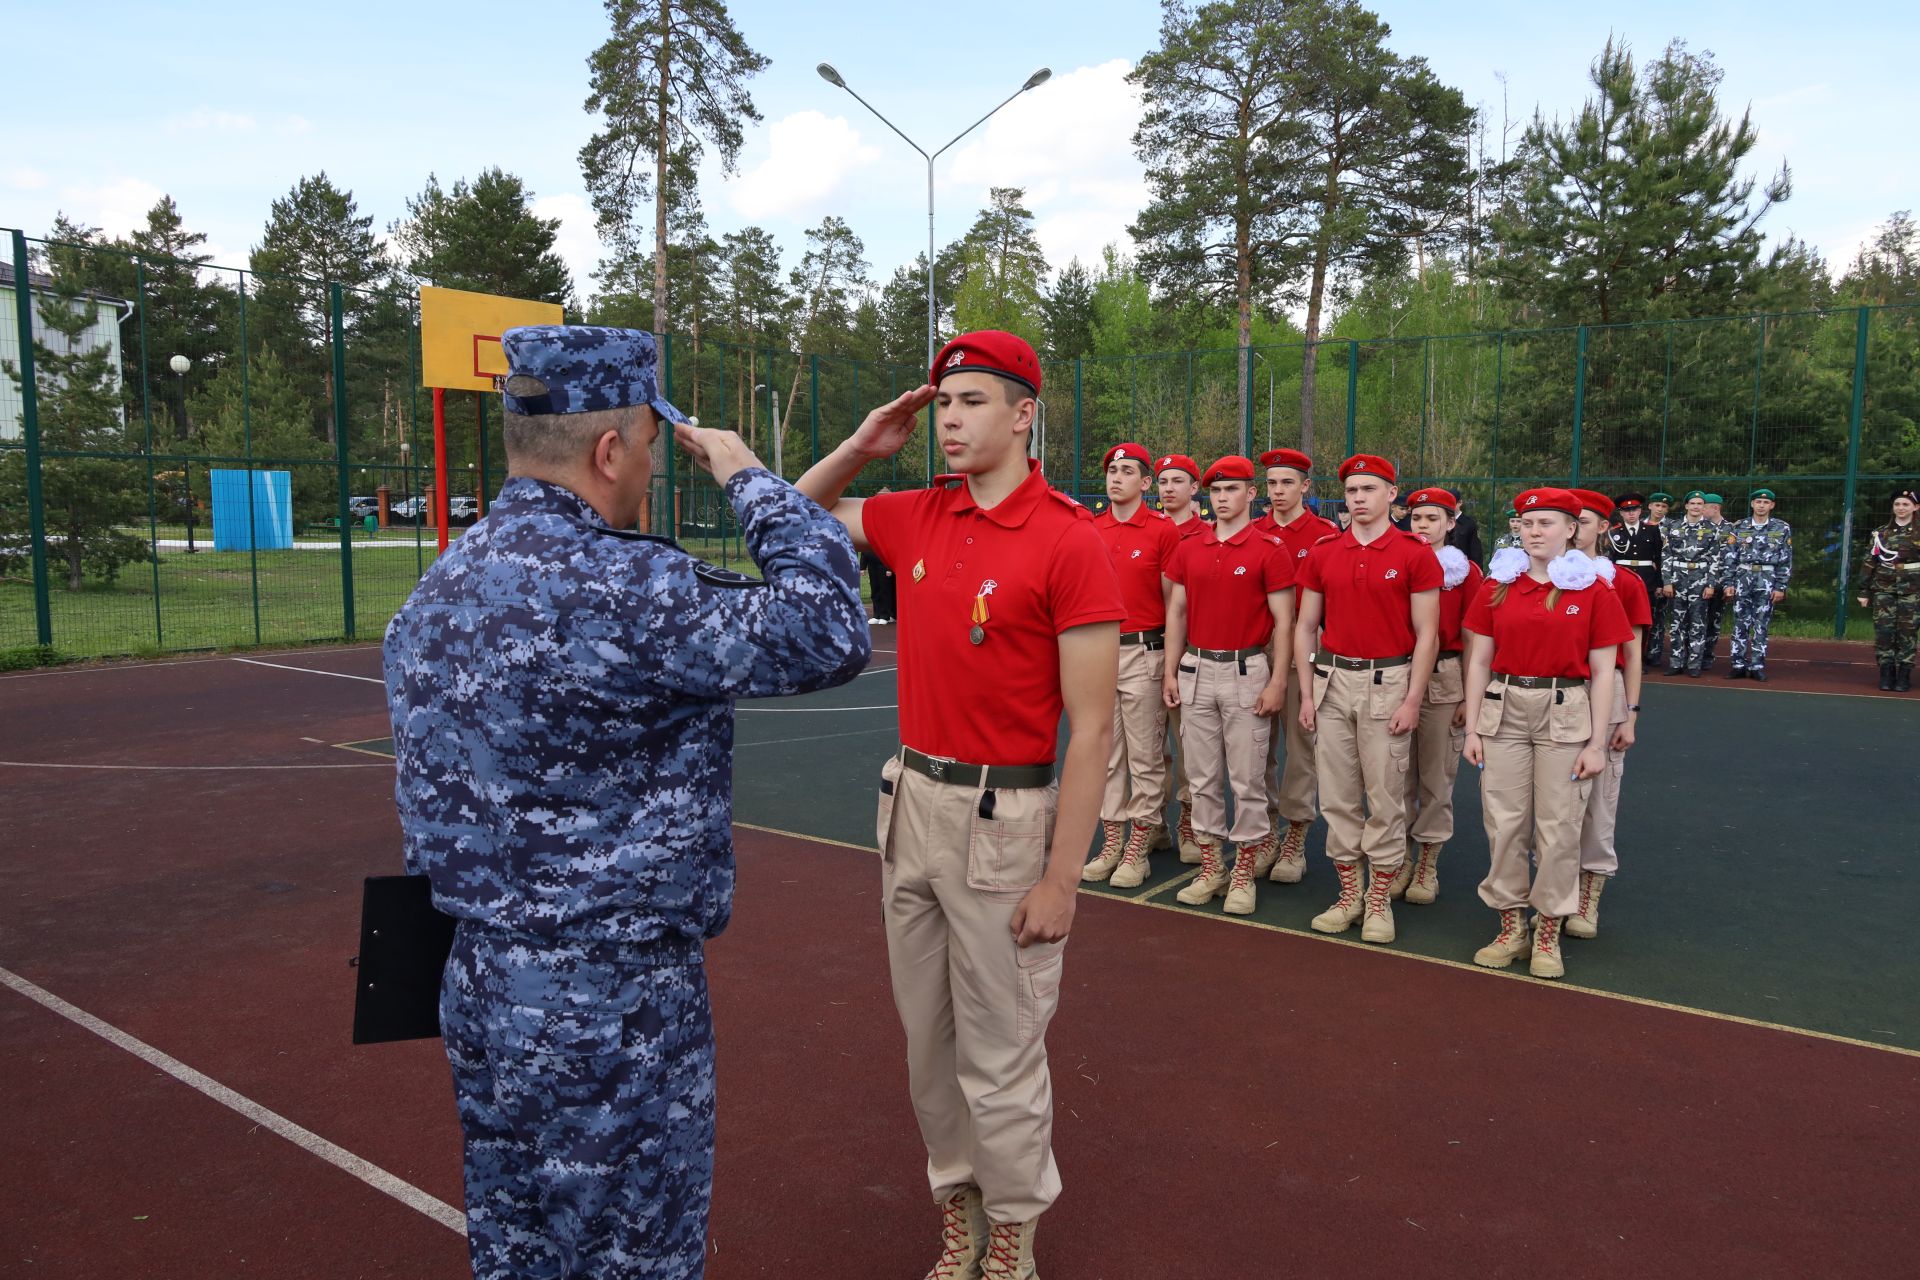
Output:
top-left (440, 923), bottom-right (714, 1280)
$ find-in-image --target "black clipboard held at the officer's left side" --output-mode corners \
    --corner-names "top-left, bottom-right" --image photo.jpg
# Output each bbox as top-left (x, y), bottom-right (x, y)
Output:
top-left (349, 875), bottom-right (455, 1044)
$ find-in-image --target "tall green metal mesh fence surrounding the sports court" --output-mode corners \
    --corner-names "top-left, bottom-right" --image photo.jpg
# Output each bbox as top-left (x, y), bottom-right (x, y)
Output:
top-left (0, 232), bottom-right (1920, 654)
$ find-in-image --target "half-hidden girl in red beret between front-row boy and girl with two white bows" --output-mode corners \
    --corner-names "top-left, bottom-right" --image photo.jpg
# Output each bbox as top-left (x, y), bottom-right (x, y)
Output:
top-left (1392, 486), bottom-right (1482, 904)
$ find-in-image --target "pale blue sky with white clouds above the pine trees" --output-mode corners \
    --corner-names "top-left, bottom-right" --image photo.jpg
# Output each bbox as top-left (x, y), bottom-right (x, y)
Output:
top-left (0, 0), bottom-right (1920, 290)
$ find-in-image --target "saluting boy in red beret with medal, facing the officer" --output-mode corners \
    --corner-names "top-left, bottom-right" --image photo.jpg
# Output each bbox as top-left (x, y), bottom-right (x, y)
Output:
top-left (799, 330), bottom-right (1125, 1276)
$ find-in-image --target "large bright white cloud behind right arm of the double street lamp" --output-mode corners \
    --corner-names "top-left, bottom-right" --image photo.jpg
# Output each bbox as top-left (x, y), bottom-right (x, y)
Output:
top-left (939, 59), bottom-right (1148, 269)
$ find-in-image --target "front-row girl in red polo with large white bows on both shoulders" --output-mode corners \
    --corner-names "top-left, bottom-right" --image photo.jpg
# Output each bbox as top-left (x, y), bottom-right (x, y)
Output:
top-left (1463, 489), bottom-right (1632, 977)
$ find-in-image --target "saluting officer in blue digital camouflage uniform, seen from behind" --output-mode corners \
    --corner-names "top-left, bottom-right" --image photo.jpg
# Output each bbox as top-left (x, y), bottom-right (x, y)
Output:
top-left (384, 324), bottom-right (870, 1280)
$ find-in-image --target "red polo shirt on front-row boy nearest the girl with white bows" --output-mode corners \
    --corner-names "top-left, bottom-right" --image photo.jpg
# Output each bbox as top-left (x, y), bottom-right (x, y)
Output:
top-left (1300, 526), bottom-right (1440, 658)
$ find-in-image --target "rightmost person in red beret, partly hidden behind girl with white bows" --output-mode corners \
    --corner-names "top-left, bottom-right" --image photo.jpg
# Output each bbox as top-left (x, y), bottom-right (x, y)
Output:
top-left (1567, 489), bottom-right (1653, 938)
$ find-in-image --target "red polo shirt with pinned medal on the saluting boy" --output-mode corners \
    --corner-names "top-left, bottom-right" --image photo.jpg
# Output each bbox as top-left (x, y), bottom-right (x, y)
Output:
top-left (860, 462), bottom-right (1125, 764)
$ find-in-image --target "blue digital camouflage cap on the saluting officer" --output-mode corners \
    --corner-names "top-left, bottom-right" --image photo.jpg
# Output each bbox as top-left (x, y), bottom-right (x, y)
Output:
top-left (499, 324), bottom-right (687, 422)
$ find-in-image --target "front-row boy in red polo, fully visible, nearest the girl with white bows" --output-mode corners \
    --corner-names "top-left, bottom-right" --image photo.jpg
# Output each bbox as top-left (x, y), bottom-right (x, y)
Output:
top-left (1294, 453), bottom-right (1440, 942)
